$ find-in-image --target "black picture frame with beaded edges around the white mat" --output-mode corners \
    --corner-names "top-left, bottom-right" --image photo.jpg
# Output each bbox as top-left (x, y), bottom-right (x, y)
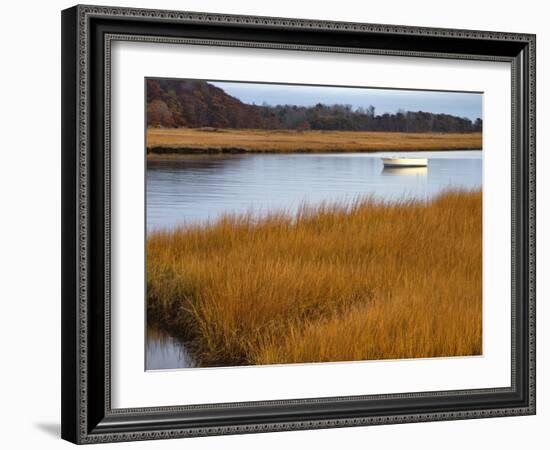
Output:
top-left (61, 5), bottom-right (535, 444)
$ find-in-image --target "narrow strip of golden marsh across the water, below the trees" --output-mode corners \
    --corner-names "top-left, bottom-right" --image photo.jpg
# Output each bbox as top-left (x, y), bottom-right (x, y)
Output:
top-left (147, 128), bottom-right (482, 154)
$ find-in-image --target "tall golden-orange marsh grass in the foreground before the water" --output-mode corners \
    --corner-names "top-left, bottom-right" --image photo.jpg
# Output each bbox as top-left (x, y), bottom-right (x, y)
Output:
top-left (147, 192), bottom-right (481, 366)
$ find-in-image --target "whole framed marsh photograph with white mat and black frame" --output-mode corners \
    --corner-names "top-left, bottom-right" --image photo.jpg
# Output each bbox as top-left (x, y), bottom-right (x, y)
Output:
top-left (62, 6), bottom-right (535, 444)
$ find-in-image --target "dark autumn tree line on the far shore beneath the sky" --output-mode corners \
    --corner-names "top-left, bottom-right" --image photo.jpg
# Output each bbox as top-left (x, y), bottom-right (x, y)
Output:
top-left (146, 79), bottom-right (483, 133)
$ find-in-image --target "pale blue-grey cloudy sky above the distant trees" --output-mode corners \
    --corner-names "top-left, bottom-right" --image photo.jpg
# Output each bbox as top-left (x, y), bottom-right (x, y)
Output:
top-left (209, 81), bottom-right (483, 120)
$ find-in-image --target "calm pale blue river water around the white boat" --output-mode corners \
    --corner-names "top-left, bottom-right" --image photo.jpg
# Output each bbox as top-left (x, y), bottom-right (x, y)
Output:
top-left (146, 151), bottom-right (482, 369)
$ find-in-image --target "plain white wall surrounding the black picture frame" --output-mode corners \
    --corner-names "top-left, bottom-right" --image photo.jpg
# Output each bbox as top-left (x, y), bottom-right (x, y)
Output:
top-left (0, 0), bottom-right (550, 450)
